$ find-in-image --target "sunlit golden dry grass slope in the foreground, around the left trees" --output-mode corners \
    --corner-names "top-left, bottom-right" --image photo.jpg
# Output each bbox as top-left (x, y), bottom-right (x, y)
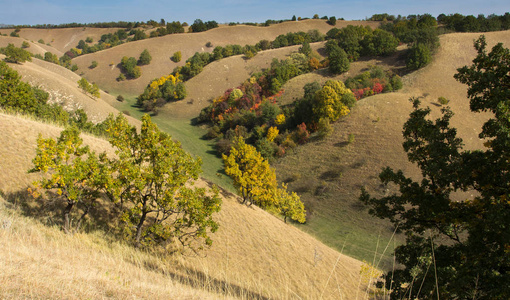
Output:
top-left (0, 114), bottom-right (370, 299)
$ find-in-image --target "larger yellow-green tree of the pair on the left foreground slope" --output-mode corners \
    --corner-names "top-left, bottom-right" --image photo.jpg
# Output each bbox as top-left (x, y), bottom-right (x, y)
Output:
top-left (107, 114), bottom-right (221, 249)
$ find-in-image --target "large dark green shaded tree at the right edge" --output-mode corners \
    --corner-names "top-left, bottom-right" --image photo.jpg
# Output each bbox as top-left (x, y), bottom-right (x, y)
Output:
top-left (361, 36), bottom-right (510, 299)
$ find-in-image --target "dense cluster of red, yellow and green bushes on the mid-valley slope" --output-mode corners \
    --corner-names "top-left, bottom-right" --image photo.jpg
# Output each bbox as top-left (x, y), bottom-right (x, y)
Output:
top-left (198, 74), bottom-right (355, 159)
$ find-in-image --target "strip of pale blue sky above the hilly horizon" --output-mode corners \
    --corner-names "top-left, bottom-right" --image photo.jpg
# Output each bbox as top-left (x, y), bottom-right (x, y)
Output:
top-left (0, 0), bottom-right (510, 25)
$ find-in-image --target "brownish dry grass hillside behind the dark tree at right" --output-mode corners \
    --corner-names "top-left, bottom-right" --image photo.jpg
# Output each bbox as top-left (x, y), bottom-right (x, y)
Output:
top-left (275, 31), bottom-right (510, 257)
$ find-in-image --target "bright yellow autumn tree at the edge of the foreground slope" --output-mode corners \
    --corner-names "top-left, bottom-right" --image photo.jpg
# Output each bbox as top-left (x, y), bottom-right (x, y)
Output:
top-left (223, 137), bottom-right (277, 208)
